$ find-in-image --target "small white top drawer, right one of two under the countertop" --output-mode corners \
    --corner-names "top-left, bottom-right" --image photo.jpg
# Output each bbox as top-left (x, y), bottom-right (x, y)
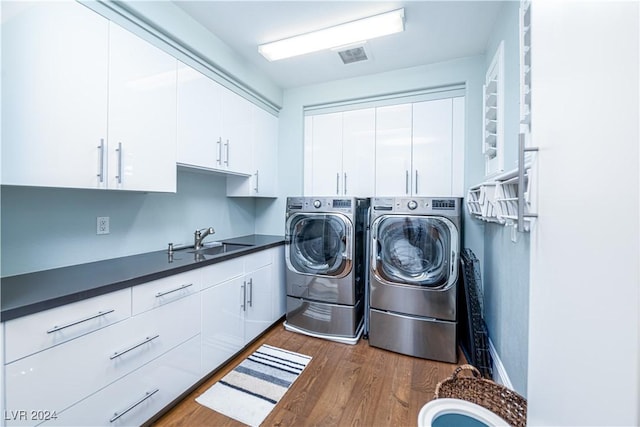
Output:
top-left (132, 269), bottom-right (201, 316)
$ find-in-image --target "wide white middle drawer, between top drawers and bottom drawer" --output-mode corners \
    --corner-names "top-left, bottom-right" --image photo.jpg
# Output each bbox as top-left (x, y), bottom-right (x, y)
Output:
top-left (5, 295), bottom-right (200, 425)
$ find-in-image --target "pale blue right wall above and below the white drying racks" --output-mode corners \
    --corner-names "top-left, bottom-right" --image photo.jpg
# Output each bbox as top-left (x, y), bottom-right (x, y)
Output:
top-left (477, 2), bottom-right (530, 396)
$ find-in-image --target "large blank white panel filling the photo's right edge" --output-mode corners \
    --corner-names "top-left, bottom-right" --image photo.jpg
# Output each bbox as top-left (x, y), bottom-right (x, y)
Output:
top-left (528, 0), bottom-right (640, 426)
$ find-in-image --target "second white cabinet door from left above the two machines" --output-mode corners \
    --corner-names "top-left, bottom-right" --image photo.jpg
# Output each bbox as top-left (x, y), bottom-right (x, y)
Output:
top-left (341, 108), bottom-right (376, 197)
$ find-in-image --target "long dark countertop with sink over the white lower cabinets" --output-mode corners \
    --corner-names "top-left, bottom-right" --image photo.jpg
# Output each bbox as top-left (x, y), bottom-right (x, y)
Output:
top-left (0, 234), bottom-right (284, 322)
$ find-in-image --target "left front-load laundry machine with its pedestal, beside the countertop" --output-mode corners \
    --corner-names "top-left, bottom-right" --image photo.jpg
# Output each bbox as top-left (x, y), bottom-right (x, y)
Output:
top-left (285, 197), bottom-right (369, 344)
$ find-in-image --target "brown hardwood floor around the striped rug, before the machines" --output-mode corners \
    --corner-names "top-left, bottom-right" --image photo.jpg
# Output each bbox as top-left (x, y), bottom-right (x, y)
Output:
top-left (153, 322), bottom-right (465, 427)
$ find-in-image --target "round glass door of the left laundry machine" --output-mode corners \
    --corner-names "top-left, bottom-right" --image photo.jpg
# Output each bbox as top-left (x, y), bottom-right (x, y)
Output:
top-left (289, 214), bottom-right (351, 277)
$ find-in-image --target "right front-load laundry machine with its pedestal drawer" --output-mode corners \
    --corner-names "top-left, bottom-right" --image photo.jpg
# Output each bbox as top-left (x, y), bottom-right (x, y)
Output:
top-left (368, 197), bottom-right (462, 362)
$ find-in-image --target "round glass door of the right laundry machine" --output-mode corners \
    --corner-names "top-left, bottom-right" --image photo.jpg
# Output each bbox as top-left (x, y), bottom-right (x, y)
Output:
top-left (375, 216), bottom-right (452, 288)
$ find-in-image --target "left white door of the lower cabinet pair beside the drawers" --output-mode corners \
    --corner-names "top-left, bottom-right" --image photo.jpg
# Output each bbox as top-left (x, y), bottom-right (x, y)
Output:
top-left (201, 276), bottom-right (244, 374)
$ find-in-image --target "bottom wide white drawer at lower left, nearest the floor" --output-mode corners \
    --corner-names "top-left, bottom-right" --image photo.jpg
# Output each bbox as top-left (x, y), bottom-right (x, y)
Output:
top-left (43, 335), bottom-right (200, 426)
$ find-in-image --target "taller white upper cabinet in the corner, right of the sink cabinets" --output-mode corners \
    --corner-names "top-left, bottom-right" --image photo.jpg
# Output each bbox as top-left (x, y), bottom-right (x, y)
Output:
top-left (227, 105), bottom-right (278, 197)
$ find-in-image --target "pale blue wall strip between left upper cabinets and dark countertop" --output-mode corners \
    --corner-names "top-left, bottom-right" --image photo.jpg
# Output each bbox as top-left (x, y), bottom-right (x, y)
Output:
top-left (0, 171), bottom-right (258, 277)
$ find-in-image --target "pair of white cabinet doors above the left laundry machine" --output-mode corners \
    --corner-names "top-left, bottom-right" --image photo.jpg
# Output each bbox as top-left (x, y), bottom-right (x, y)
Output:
top-left (305, 108), bottom-right (375, 197)
